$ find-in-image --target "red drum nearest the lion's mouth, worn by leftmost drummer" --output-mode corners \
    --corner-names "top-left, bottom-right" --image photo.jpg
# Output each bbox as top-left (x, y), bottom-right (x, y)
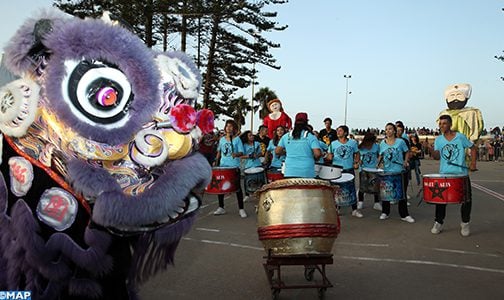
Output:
top-left (205, 167), bottom-right (240, 195)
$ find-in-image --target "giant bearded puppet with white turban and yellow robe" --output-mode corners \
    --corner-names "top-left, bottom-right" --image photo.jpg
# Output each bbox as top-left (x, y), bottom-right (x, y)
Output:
top-left (438, 83), bottom-right (483, 142)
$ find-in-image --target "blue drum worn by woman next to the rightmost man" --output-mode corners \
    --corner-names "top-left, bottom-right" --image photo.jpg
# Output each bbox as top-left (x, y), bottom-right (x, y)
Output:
top-left (377, 172), bottom-right (406, 203)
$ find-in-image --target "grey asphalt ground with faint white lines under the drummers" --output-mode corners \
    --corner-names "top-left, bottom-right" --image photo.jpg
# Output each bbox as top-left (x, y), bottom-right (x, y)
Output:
top-left (140, 159), bottom-right (504, 300)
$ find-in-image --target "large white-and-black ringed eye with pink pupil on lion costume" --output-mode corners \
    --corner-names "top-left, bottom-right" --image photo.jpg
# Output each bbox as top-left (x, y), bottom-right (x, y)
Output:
top-left (62, 60), bottom-right (133, 127)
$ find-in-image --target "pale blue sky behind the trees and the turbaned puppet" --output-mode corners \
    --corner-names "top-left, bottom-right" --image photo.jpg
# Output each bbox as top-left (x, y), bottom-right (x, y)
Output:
top-left (0, 0), bottom-right (504, 131)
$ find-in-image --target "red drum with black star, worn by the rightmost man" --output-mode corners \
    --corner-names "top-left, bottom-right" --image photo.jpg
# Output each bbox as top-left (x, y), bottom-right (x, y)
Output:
top-left (422, 174), bottom-right (469, 204)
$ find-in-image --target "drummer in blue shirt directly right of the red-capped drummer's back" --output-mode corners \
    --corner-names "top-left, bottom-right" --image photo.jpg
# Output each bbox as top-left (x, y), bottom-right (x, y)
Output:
top-left (327, 125), bottom-right (364, 218)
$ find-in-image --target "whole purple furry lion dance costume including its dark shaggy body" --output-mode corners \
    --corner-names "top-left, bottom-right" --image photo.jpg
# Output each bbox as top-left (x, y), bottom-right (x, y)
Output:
top-left (0, 11), bottom-right (213, 299)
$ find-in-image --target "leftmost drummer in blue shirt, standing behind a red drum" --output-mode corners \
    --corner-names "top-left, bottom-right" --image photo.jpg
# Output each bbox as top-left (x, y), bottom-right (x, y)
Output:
top-left (214, 120), bottom-right (247, 218)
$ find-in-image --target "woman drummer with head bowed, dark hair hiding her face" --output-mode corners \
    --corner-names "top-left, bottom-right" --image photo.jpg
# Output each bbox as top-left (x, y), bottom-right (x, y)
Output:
top-left (357, 132), bottom-right (382, 211)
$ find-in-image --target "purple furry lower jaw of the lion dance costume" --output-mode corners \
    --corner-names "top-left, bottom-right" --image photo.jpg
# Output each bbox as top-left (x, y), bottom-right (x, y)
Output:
top-left (68, 153), bottom-right (212, 232)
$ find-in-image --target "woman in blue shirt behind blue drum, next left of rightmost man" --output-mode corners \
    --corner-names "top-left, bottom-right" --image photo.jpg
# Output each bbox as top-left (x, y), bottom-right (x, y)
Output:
top-left (378, 123), bottom-right (415, 223)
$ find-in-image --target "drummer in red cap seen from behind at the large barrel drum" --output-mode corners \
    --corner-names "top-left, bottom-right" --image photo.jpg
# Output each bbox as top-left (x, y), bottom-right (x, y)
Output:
top-left (275, 112), bottom-right (322, 178)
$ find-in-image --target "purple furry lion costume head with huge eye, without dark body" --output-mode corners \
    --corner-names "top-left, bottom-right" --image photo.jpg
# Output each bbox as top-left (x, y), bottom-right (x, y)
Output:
top-left (0, 12), bottom-right (213, 231)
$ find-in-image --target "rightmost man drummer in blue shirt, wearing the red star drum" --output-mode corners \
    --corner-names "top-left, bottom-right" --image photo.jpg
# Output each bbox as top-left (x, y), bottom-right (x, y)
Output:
top-left (431, 115), bottom-right (476, 236)
